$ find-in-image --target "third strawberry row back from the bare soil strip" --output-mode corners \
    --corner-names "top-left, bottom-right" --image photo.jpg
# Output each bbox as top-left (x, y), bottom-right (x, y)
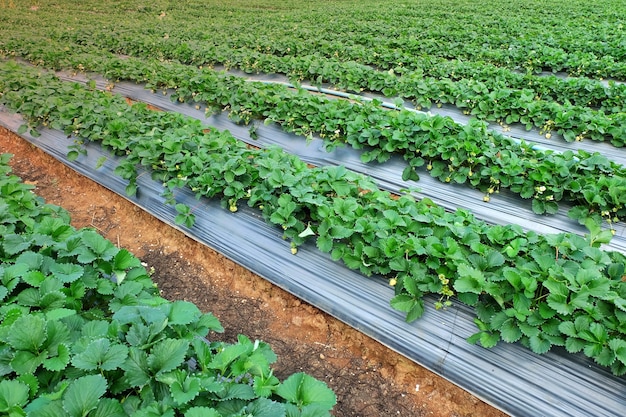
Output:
top-left (30, 32), bottom-right (626, 147)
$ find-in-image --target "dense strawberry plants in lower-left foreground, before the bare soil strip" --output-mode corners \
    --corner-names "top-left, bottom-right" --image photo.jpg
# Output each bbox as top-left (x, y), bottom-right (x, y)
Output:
top-left (0, 154), bottom-right (336, 417)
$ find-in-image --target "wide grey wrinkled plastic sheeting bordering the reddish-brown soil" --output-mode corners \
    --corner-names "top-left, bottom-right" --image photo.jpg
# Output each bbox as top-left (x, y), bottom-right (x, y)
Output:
top-left (0, 112), bottom-right (626, 417)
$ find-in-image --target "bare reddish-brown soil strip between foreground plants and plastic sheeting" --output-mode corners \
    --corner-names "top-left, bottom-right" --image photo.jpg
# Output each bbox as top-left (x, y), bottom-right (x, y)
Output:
top-left (0, 128), bottom-right (505, 417)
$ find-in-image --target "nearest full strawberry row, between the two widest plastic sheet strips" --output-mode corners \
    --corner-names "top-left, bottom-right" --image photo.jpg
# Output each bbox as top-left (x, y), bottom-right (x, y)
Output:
top-left (3, 63), bottom-right (626, 374)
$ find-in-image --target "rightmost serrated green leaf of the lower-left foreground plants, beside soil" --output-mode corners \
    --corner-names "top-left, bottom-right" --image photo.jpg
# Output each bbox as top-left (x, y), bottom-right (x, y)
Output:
top-left (276, 372), bottom-right (337, 410)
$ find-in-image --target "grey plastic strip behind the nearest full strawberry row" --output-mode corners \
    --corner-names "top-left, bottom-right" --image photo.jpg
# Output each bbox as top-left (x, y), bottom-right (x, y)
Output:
top-left (89, 79), bottom-right (626, 253)
